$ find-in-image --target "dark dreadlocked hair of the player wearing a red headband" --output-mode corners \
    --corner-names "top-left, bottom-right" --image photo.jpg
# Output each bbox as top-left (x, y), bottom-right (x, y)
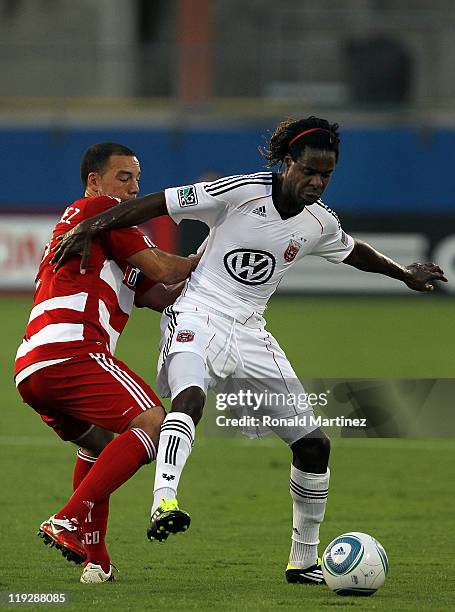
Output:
top-left (259, 116), bottom-right (340, 168)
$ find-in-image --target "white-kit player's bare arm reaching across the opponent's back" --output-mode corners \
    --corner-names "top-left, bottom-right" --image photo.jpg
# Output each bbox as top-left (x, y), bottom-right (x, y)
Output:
top-left (51, 192), bottom-right (168, 274)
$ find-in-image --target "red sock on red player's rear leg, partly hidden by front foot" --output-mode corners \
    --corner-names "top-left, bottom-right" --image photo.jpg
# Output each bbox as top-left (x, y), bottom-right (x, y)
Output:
top-left (73, 449), bottom-right (111, 574)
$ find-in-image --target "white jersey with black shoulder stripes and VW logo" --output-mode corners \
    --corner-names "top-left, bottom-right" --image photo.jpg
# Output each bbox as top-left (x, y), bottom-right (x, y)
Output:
top-left (165, 172), bottom-right (354, 322)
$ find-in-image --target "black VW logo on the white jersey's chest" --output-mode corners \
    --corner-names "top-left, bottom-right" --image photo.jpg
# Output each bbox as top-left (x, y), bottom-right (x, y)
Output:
top-left (224, 249), bottom-right (275, 285)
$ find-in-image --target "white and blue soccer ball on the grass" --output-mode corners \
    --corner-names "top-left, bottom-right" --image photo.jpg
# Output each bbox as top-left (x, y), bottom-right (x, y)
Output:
top-left (322, 531), bottom-right (389, 596)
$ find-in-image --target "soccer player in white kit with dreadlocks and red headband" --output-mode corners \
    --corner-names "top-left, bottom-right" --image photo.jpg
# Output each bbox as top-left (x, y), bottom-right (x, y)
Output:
top-left (51, 117), bottom-right (445, 584)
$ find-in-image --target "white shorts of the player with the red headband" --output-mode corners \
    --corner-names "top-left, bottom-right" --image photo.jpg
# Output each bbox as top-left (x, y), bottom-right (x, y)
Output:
top-left (157, 302), bottom-right (316, 444)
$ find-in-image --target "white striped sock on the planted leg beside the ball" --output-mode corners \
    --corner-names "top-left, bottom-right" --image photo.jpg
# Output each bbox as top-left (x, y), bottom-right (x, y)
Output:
top-left (289, 465), bottom-right (330, 569)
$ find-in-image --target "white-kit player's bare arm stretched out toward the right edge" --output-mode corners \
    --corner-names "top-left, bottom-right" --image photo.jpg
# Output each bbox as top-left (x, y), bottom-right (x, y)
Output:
top-left (343, 240), bottom-right (447, 291)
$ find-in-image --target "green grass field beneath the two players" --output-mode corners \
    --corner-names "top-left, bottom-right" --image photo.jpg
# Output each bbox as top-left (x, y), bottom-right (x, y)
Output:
top-left (0, 296), bottom-right (455, 612)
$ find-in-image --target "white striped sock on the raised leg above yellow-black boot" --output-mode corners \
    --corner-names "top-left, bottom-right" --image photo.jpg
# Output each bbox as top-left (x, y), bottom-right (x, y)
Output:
top-left (152, 412), bottom-right (194, 514)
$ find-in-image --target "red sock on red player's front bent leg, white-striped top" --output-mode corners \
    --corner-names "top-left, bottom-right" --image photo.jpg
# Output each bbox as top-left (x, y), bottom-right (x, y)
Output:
top-left (55, 427), bottom-right (156, 525)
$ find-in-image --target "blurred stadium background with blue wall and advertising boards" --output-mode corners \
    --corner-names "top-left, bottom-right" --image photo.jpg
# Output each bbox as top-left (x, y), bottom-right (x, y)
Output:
top-left (0, 0), bottom-right (455, 294)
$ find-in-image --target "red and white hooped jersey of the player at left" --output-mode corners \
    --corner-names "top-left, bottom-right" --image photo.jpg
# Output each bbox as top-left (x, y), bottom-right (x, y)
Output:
top-left (14, 196), bottom-right (155, 384)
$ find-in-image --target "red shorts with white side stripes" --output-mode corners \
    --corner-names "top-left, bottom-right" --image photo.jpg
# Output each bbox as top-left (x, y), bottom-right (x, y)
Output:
top-left (18, 353), bottom-right (161, 440)
